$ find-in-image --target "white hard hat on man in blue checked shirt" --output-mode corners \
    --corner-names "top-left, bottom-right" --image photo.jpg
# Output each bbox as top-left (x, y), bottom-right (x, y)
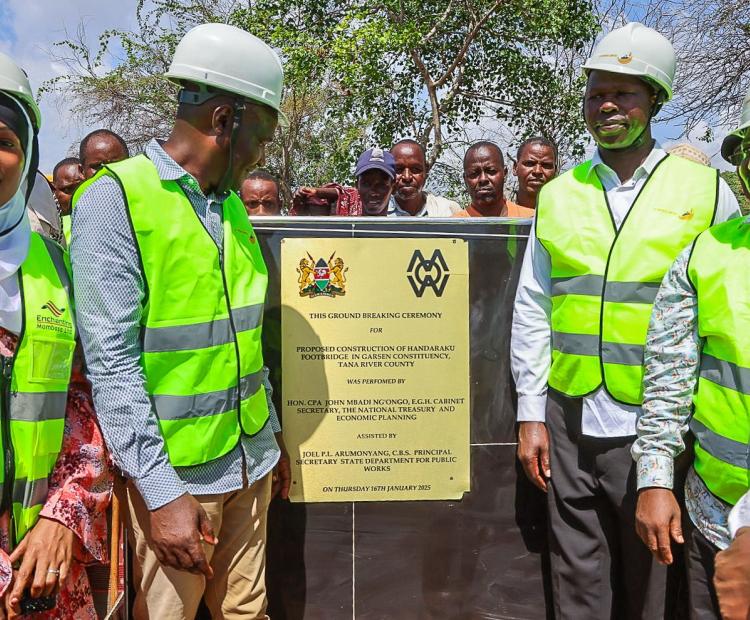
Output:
top-left (165, 24), bottom-right (286, 125)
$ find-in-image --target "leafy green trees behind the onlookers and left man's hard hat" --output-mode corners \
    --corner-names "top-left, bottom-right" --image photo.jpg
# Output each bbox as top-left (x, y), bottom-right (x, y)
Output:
top-left (47, 0), bottom-right (596, 195)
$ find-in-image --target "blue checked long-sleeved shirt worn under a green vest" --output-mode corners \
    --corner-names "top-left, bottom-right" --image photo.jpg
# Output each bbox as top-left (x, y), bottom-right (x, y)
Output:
top-left (70, 140), bottom-right (281, 510)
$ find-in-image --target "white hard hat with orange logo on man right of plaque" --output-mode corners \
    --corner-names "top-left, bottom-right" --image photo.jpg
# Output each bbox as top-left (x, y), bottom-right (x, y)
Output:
top-left (583, 22), bottom-right (677, 102)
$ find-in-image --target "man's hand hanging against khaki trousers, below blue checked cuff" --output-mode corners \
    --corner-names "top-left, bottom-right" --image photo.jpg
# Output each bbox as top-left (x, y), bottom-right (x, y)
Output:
top-left (149, 493), bottom-right (218, 579)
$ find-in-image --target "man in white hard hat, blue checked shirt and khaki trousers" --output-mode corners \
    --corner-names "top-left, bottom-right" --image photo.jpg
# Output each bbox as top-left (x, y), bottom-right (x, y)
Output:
top-left (71, 24), bottom-right (290, 620)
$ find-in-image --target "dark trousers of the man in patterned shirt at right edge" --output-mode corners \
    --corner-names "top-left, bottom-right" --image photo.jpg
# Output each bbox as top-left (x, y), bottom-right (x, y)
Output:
top-left (683, 515), bottom-right (721, 620)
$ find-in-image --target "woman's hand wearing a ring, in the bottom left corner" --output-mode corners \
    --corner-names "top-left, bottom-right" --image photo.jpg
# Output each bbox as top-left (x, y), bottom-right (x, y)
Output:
top-left (5, 517), bottom-right (76, 617)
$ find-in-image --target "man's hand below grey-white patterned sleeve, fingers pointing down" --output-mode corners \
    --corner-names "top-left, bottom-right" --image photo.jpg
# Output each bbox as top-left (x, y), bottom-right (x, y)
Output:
top-left (635, 488), bottom-right (685, 565)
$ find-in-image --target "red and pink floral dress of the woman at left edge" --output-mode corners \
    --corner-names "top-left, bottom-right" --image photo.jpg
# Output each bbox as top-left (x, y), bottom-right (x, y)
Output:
top-left (0, 328), bottom-right (113, 620)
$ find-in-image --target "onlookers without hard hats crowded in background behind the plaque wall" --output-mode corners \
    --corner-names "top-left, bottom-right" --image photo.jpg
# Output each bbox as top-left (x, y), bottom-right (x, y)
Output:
top-left (45, 129), bottom-right (558, 225)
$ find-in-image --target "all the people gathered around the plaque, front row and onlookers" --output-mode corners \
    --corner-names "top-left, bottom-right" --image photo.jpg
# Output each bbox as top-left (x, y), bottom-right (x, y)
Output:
top-left (0, 12), bottom-right (750, 619)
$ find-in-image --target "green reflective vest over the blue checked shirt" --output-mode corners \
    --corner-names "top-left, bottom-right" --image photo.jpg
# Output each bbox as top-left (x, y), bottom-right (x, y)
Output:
top-left (73, 155), bottom-right (269, 467)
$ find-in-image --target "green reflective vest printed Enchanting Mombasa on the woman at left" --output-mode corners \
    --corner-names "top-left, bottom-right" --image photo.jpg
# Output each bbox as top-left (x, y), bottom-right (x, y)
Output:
top-left (0, 233), bottom-right (75, 541)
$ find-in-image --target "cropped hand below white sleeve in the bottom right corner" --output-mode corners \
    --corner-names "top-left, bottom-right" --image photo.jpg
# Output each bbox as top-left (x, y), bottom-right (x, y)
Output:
top-left (714, 527), bottom-right (750, 620)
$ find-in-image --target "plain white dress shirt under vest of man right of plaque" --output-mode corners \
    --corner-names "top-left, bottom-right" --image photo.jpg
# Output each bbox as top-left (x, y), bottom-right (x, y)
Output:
top-left (510, 143), bottom-right (740, 437)
